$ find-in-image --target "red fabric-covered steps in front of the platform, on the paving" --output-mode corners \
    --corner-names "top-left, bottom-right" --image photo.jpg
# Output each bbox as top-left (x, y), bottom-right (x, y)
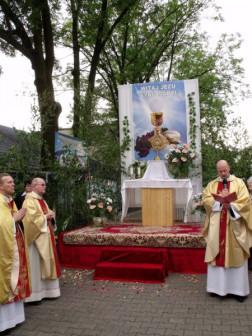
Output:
top-left (94, 248), bottom-right (167, 283)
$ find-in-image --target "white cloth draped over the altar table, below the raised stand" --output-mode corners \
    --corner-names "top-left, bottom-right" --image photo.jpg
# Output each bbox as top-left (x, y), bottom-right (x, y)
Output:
top-left (121, 178), bottom-right (193, 223)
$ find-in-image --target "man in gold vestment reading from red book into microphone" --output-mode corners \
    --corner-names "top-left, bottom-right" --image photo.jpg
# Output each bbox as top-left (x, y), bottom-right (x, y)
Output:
top-left (203, 160), bottom-right (252, 302)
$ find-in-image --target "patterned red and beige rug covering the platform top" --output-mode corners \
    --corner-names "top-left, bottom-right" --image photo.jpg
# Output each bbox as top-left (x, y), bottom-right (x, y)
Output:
top-left (63, 223), bottom-right (206, 248)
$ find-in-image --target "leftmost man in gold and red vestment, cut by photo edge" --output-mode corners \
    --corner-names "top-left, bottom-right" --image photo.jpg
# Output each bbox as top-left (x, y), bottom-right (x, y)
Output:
top-left (0, 174), bottom-right (30, 332)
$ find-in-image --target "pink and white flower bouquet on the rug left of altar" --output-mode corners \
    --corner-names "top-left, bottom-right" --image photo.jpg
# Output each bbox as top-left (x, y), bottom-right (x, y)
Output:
top-left (87, 194), bottom-right (114, 225)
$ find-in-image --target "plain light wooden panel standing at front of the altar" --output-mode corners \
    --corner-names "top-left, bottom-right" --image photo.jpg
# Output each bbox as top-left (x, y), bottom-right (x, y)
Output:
top-left (142, 188), bottom-right (174, 226)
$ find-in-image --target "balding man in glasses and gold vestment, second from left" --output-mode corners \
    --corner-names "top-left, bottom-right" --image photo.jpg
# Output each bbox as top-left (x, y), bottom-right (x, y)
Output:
top-left (23, 178), bottom-right (60, 302)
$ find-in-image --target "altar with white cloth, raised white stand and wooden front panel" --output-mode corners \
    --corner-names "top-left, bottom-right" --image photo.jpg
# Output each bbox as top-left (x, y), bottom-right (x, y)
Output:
top-left (121, 160), bottom-right (193, 226)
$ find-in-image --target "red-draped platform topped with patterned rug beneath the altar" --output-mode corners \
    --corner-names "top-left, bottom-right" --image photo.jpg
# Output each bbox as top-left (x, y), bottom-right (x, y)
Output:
top-left (58, 223), bottom-right (206, 281)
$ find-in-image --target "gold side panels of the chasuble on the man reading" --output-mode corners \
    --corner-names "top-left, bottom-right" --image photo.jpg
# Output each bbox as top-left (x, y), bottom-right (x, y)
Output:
top-left (203, 175), bottom-right (252, 268)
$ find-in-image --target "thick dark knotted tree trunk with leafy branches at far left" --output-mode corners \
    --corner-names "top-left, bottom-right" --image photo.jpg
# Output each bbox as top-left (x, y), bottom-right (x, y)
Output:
top-left (0, 0), bottom-right (61, 166)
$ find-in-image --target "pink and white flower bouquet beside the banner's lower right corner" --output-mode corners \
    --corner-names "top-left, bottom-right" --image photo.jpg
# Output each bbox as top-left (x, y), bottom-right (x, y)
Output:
top-left (168, 144), bottom-right (196, 178)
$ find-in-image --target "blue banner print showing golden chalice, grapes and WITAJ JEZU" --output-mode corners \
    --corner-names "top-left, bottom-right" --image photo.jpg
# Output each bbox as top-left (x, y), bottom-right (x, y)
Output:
top-left (132, 81), bottom-right (187, 160)
